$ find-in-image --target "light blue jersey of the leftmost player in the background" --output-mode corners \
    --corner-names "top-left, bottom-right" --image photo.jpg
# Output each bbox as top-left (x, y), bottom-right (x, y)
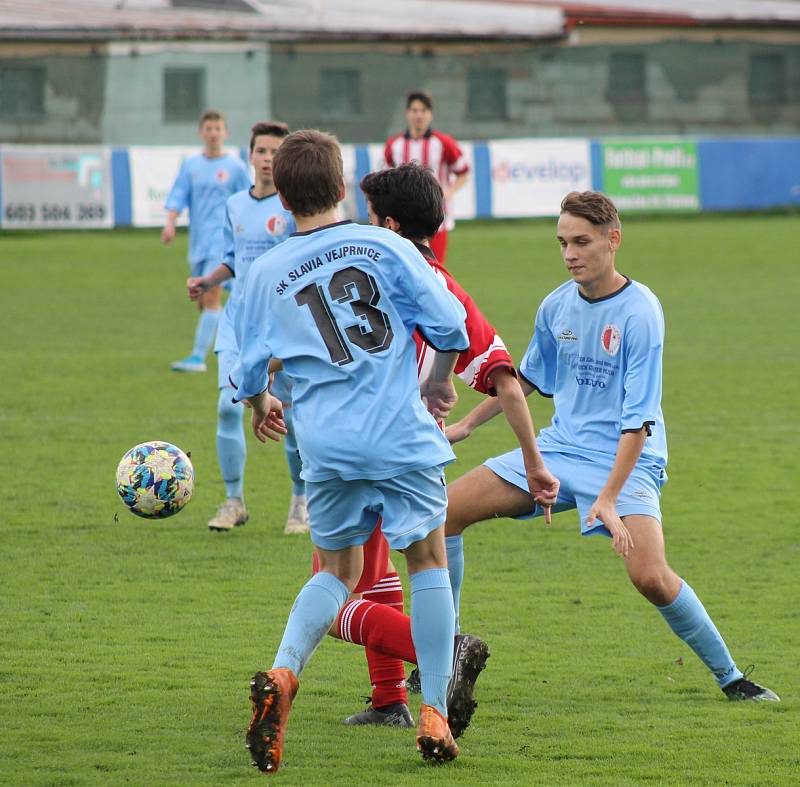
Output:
top-left (165, 153), bottom-right (250, 266)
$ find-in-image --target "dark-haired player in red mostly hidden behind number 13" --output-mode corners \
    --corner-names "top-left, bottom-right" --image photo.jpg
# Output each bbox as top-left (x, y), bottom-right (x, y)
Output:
top-left (322, 164), bottom-right (558, 737)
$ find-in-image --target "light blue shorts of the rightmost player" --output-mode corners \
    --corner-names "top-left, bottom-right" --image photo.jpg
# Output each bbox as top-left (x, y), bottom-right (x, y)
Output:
top-left (484, 448), bottom-right (667, 536)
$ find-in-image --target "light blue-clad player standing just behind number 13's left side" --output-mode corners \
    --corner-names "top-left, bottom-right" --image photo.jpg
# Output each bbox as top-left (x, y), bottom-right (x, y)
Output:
top-left (187, 121), bottom-right (308, 533)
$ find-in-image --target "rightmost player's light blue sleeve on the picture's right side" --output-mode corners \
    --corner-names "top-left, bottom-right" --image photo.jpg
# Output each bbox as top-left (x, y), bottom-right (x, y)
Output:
top-left (620, 307), bottom-right (664, 435)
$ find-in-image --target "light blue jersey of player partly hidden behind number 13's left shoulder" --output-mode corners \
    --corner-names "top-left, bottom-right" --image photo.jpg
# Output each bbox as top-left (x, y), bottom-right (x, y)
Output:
top-left (214, 189), bottom-right (297, 352)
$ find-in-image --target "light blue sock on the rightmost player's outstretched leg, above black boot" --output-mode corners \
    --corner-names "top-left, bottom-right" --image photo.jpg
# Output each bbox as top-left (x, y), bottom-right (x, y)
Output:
top-left (657, 580), bottom-right (742, 688)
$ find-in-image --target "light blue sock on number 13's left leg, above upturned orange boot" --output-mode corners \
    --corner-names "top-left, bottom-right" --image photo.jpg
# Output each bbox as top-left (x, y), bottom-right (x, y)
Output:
top-left (272, 571), bottom-right (350, 676)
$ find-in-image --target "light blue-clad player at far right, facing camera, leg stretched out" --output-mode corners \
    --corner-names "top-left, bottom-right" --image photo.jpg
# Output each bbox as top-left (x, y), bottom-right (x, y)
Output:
top-left (446, 192), bottom-right (778, 701)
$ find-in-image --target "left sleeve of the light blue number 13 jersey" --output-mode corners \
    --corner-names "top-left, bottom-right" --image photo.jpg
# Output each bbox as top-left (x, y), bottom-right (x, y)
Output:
top-left (230, 265), bottom-right (272, 402)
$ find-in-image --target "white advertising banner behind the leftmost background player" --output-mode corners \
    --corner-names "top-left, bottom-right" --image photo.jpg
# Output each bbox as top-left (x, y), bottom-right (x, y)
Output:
top-left (128, 145), bottom-right (244, 227)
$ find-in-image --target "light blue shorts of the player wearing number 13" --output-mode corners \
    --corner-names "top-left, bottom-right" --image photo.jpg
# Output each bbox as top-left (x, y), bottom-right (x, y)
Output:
top-left (306, 467), bottom-right (447, 550)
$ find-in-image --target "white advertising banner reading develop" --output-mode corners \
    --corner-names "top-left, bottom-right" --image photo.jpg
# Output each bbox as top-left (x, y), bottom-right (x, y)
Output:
top-left (489, 139), bottom-right (592, 218)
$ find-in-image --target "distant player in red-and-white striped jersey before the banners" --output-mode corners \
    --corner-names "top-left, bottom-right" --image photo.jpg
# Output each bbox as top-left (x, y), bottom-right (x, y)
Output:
top-left (384, 90), bottom-right (469, 263)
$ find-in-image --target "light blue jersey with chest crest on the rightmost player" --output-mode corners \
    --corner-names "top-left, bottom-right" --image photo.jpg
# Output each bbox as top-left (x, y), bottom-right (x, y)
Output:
top-left (520, 280), bottom-right (667, 478)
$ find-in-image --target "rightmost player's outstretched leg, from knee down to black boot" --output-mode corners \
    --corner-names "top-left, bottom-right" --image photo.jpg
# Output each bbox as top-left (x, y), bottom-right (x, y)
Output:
top-left (623, 516), bottom-right (780, 702)
